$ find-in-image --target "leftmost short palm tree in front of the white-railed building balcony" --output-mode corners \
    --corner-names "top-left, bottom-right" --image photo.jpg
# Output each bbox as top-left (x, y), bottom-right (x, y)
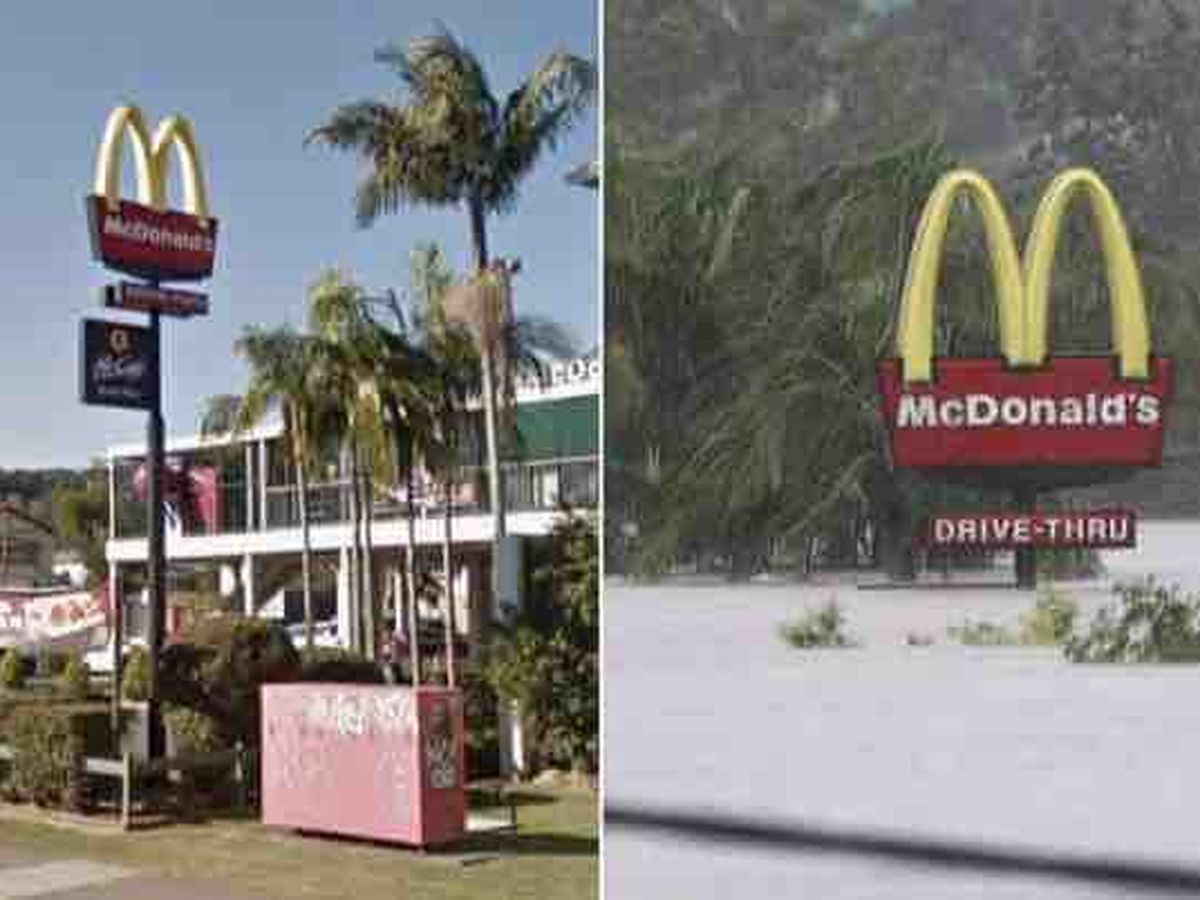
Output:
top-left (200, 326), bottom-right (328, 650)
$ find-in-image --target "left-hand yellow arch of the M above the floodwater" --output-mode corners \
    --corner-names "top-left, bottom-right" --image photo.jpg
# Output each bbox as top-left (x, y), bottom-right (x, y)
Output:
top-left (896, 169), bottom-right (1026, 382)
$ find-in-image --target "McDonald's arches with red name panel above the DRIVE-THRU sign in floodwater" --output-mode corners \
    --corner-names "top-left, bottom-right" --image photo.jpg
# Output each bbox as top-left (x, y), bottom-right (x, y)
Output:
top-left (877, 169), bottom-right (1171, 485)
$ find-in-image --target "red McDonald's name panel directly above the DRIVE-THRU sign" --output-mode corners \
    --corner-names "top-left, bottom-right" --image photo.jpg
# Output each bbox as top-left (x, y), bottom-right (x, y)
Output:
top-left (878, 356), bottom-right (1171, 469)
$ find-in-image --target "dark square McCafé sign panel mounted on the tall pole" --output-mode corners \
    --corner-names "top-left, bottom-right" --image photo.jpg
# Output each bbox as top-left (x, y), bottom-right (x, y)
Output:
top-left (79, 319), bottom-right (158, 409)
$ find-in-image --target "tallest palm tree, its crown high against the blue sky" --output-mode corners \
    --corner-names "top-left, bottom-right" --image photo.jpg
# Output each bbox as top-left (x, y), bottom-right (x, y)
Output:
top-left (308, 29), bottom-right (595, 619)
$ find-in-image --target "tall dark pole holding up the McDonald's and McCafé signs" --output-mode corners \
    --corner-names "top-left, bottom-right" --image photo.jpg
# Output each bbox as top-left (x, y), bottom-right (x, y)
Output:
top-left (146, 309), bottom-right (167, 760)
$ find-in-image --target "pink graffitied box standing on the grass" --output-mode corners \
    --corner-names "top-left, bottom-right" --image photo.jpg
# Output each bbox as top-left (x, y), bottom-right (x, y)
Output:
top-left (263, 683), bottom-right (467, 847)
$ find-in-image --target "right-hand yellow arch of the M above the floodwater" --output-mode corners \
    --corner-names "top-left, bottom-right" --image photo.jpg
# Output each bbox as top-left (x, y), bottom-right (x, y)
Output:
top-left (1025, 169), bottom-right (1150, 378)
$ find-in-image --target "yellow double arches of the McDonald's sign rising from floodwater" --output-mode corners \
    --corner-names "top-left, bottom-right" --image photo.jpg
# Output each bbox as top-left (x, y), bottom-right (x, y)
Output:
top-left (896, 168), bottom-right (1150, 383)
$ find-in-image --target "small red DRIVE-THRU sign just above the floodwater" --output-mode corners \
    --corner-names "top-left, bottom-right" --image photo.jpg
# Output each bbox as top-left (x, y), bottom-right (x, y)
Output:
top-left (924, 510), bottom-right (1138, 550)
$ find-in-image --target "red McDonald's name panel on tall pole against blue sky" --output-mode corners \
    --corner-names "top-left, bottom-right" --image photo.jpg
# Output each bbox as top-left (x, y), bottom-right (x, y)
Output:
top-left (88, 194), bottom-right (217, 281)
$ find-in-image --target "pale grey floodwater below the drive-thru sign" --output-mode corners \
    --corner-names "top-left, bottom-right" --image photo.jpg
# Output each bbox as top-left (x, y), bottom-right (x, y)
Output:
top-left (604, 523), bottom-right (1200, 900)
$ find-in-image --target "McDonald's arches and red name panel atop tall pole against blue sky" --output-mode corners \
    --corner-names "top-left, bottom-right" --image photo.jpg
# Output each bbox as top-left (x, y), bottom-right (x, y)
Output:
top-left (88, 107), bottom-right (217, 281)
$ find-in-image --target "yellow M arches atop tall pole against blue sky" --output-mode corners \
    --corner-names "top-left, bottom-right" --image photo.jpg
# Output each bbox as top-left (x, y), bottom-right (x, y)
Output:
top-left (95, 106), bottom-right (209, 220)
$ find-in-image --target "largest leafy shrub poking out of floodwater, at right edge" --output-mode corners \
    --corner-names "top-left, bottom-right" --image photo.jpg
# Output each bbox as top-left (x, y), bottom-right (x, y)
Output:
top-left (1064, 580), bottom-right (1200, 662)
